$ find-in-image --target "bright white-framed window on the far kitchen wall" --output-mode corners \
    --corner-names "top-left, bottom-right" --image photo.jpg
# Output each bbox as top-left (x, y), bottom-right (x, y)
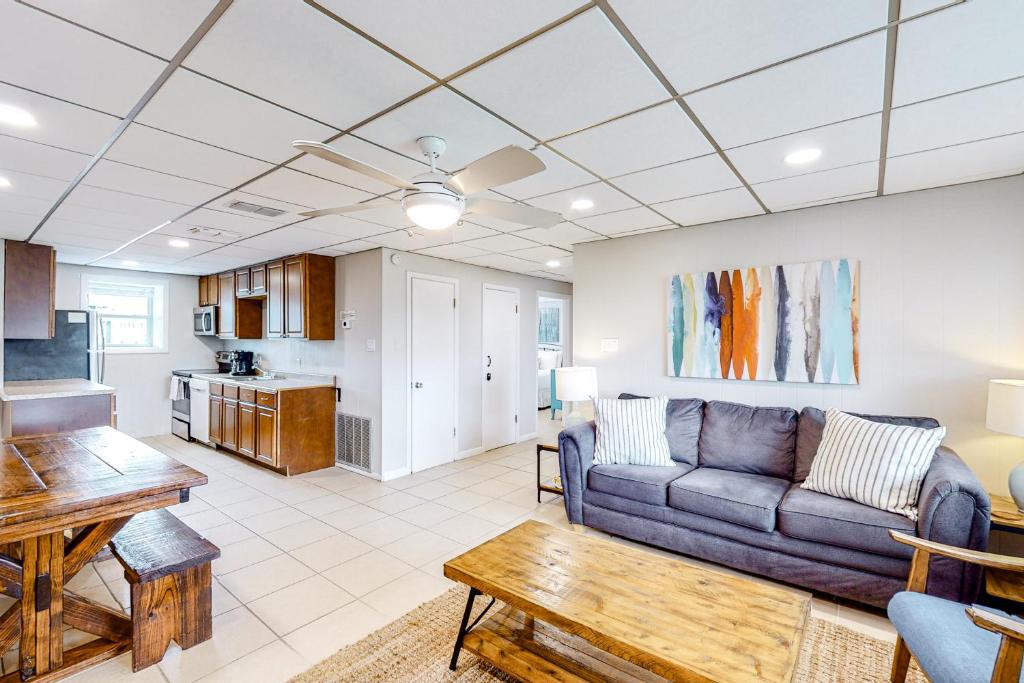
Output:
top-left (82, 274), bottom-right (168, 353)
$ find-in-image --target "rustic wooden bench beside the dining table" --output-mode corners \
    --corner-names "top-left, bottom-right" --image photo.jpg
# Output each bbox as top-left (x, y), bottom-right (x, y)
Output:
top-left (110, 510), bottom-right (220, 671)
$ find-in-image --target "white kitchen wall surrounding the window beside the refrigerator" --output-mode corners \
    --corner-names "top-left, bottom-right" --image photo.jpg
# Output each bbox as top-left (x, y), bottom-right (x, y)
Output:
top-left (56, 263), bottom-right (220, 436)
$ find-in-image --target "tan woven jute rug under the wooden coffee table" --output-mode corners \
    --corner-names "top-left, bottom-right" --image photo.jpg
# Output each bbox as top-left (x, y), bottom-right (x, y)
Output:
top-left (291, 587), bottom-right (927, 683)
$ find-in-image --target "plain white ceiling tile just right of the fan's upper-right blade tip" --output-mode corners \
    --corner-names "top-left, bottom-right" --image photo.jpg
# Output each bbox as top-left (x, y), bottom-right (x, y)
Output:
top-left (551, 102), bottom-right (714, 178)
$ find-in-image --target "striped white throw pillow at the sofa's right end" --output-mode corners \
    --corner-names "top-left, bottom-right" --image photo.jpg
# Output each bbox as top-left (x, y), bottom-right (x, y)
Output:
top-left (802, 408), bottom-right (946, 521)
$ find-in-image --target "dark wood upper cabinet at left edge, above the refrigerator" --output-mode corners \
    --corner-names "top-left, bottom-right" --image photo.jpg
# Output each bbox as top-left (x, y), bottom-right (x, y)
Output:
top-left (3, 240), bottom-right (55, 339)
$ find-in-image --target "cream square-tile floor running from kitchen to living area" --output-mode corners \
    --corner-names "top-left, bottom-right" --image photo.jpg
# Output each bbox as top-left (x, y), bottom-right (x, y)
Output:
top-left (0, 413), bottom-right (895, 683)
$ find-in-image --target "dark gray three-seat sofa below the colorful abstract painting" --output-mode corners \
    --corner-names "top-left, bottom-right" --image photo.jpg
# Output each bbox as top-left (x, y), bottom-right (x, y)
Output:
top-left (558, 394), bottom-right (991, 607)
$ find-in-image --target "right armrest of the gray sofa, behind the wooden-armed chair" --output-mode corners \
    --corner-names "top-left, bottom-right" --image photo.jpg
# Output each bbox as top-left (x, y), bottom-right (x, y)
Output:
top-left (918, 446), bottom-right (992, 602)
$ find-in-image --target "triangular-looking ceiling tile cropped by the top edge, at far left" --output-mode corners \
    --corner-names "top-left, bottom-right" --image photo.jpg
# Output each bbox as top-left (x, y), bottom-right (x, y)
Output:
top-left (27, 0), bottom-right (217, 59)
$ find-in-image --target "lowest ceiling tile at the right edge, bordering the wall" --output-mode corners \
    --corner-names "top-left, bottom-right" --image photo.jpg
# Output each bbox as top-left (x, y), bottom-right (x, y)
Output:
top-left (886, 133), bottom-right (1024, 195)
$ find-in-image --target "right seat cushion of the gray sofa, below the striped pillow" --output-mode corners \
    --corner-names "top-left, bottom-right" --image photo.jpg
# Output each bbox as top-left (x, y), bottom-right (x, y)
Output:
top-left (778, 484), bottom-right (916, 558)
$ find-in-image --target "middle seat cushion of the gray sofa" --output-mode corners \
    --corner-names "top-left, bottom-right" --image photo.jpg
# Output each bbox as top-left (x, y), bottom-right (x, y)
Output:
top-left (669, 467), bottom-right (790, 531)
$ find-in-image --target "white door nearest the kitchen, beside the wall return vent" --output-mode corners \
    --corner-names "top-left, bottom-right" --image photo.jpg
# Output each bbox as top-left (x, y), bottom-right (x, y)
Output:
top-left (409, 276), bottom-right (456, 472)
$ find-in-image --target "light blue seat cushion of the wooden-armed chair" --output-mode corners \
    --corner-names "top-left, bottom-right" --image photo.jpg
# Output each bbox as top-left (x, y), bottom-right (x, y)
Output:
top-left (887, 592), bottom-right (1011, 683)
